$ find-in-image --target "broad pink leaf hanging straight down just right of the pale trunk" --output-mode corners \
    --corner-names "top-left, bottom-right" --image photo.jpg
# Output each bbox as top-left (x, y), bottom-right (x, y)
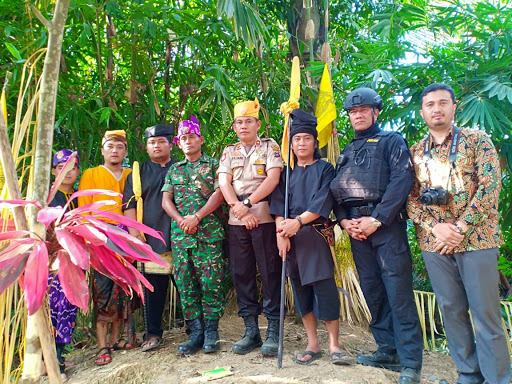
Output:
top-left (57, 251), bottom-right (89, 312)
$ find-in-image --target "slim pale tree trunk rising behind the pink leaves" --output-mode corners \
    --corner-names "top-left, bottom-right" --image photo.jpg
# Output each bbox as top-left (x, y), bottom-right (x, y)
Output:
top-left (22, 0), bottom-right (69, 384)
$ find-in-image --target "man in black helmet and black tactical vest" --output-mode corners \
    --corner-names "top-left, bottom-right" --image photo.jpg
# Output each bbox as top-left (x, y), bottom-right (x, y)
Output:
top-left (331, 88), bottom-right (423, 384)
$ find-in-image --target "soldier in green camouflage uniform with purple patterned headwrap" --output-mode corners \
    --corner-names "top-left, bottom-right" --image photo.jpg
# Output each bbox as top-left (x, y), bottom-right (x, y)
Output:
top-left (162, 116), bottom-right (225, 355)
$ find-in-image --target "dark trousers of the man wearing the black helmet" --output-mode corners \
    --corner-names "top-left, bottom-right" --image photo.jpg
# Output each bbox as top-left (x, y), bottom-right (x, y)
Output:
top-left (350, 222), bottom-right (423, 369)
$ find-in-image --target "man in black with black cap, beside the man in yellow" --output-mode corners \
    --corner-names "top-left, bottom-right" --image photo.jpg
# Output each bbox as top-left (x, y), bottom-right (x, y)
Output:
top-left (123, 124), bottom-right (175, 351)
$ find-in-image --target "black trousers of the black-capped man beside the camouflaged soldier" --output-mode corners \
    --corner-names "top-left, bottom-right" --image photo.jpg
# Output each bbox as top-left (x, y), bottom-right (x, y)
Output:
top-left (144, 273), bottom-right (171, 340)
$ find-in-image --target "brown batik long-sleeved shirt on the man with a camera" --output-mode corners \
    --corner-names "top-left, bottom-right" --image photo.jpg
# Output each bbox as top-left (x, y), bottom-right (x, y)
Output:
top-left (407, 129), bottom-right (503, 252)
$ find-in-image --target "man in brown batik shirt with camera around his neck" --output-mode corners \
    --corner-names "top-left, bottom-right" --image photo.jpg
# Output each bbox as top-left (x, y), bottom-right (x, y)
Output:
top-left (407, 84), bottom-right (510, 384)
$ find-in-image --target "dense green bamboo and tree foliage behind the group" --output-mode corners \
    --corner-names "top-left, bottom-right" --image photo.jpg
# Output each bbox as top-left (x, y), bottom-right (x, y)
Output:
top-left (0, 0), bottom-right (512, 256)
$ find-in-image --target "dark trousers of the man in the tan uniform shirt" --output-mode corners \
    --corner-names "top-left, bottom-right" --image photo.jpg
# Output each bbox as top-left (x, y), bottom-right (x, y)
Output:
top-left (229, 223), bottom-right (282, 320)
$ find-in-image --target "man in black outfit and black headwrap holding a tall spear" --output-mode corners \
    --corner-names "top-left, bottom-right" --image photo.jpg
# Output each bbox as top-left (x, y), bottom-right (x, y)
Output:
top-left (270, 109), bottom-right (350, 365)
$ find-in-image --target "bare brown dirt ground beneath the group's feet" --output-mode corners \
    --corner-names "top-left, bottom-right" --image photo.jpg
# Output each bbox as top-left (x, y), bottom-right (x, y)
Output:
top-left (56, 314), bottom-right (457, 384)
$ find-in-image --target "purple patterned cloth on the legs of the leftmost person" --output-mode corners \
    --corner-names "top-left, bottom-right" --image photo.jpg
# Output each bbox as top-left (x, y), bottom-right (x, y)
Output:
top-left (48, 274), bottom-right (78, 344)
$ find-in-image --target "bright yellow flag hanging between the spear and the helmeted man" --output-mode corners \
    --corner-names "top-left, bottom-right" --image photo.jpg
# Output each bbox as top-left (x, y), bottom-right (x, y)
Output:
top-left (315, 64), bottom-right (337, 148)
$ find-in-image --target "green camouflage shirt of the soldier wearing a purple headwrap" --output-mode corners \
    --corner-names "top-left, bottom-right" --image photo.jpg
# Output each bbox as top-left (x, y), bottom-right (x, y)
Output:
top-left (162, 154), bottom-right (224, 248)
